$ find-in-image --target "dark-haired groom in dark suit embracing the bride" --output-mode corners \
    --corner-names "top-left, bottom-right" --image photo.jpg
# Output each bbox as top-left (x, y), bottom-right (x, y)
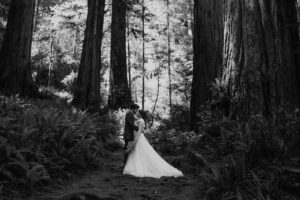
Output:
top-left (124, 103), bottom-right (139, 165)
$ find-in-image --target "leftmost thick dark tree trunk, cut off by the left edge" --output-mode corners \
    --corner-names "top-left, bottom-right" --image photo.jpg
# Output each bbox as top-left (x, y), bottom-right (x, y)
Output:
top-left (0, 0), bottom-right (37, 96)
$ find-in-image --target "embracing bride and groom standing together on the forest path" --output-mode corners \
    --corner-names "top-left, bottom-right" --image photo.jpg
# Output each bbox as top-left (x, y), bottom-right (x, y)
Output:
top-left (123, 104), bottom-right (183, 178)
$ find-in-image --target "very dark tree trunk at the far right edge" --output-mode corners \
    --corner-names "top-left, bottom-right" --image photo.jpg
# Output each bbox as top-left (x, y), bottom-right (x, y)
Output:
top-left (278, 0), bottom-right (300, 107)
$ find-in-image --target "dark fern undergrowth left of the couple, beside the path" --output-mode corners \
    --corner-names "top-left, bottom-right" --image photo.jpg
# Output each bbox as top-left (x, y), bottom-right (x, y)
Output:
top-left (0, 96), bottom-right (117, 196)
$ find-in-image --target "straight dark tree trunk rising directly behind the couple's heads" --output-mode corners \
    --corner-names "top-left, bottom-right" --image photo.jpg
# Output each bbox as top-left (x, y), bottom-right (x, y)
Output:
top-left (108, 0), bottom-right (131, 109)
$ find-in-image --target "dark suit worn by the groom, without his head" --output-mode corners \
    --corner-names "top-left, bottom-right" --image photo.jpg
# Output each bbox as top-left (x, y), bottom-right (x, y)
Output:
top-left (124, 110), bottom-right (139, 164)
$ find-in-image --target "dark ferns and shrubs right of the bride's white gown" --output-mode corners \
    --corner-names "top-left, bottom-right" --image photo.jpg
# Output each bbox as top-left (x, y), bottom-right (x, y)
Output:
top-left (147, 106), bottom-right (300, 200)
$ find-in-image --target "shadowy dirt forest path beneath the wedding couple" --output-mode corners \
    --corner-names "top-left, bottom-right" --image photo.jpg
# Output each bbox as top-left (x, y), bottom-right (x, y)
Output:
top-left (26, 151), bottom-right (201, 200)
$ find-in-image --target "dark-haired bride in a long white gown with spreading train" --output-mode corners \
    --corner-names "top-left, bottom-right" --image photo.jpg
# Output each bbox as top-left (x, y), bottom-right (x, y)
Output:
top-left (123, 110), bottom-right (183, 178)
